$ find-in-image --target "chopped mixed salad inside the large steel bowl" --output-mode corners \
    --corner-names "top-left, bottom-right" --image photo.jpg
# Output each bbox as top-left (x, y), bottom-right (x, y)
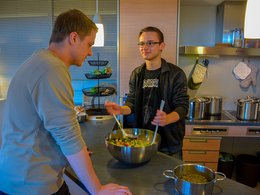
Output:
top-left (108, 137), bottom-right (151, 147)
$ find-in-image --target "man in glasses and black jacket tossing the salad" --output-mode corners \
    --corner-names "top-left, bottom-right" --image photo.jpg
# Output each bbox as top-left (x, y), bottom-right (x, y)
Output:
top-left (105, 26), bottom-right (189, 159)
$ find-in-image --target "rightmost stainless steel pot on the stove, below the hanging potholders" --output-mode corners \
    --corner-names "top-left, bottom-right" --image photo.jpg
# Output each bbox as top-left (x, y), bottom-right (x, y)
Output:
top-left (236, 97), bottom-right (260, 120)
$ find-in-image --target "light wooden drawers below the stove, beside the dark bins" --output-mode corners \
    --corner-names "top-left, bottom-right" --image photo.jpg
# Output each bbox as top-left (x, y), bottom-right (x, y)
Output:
top-left (183, 136), bottom-right (221, 171)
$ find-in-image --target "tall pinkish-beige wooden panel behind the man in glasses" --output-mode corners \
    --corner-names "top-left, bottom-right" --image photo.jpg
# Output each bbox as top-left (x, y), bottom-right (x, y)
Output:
top-left (119, 0), bottom-right (178, 97)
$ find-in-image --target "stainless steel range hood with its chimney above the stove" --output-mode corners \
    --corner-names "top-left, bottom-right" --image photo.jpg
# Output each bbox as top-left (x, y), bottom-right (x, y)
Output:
top-left (179, 1), bottom-right (260, 56)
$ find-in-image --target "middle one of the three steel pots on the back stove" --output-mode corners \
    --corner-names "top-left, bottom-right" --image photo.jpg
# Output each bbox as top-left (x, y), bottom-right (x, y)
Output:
top-left (204, 96), bottom-right (222, 116)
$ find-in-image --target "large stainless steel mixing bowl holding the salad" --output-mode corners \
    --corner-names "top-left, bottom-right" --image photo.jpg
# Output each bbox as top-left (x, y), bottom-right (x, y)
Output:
top-left (105, 128), bottom-right (161, 164)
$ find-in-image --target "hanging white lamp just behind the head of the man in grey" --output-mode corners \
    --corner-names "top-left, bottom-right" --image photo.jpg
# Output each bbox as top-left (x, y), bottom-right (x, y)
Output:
top-left (93, 0), bottom-right (104, 47)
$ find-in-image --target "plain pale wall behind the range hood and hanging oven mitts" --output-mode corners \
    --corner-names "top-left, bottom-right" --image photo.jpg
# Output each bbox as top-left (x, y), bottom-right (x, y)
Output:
top-left (179, 6), bottom-right (260, 110)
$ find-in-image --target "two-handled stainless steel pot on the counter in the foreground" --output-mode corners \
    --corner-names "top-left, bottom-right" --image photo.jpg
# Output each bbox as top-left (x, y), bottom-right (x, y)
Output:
top-left (163, 164), bottom-right (226, 195)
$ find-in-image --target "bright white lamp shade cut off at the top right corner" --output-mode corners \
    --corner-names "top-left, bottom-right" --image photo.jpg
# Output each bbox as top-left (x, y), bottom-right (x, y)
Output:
top-left (244, 0), bottom-right (260, 39)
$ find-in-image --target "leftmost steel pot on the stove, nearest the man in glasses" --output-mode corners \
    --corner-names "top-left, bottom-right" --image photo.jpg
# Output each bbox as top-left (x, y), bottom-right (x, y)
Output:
top-left (189, 98), bottom-right (207, 120)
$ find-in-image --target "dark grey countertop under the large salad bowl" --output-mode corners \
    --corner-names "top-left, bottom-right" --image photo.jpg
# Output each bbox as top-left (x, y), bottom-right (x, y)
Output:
top-left (65, 119), bottom-right (259, 195)
